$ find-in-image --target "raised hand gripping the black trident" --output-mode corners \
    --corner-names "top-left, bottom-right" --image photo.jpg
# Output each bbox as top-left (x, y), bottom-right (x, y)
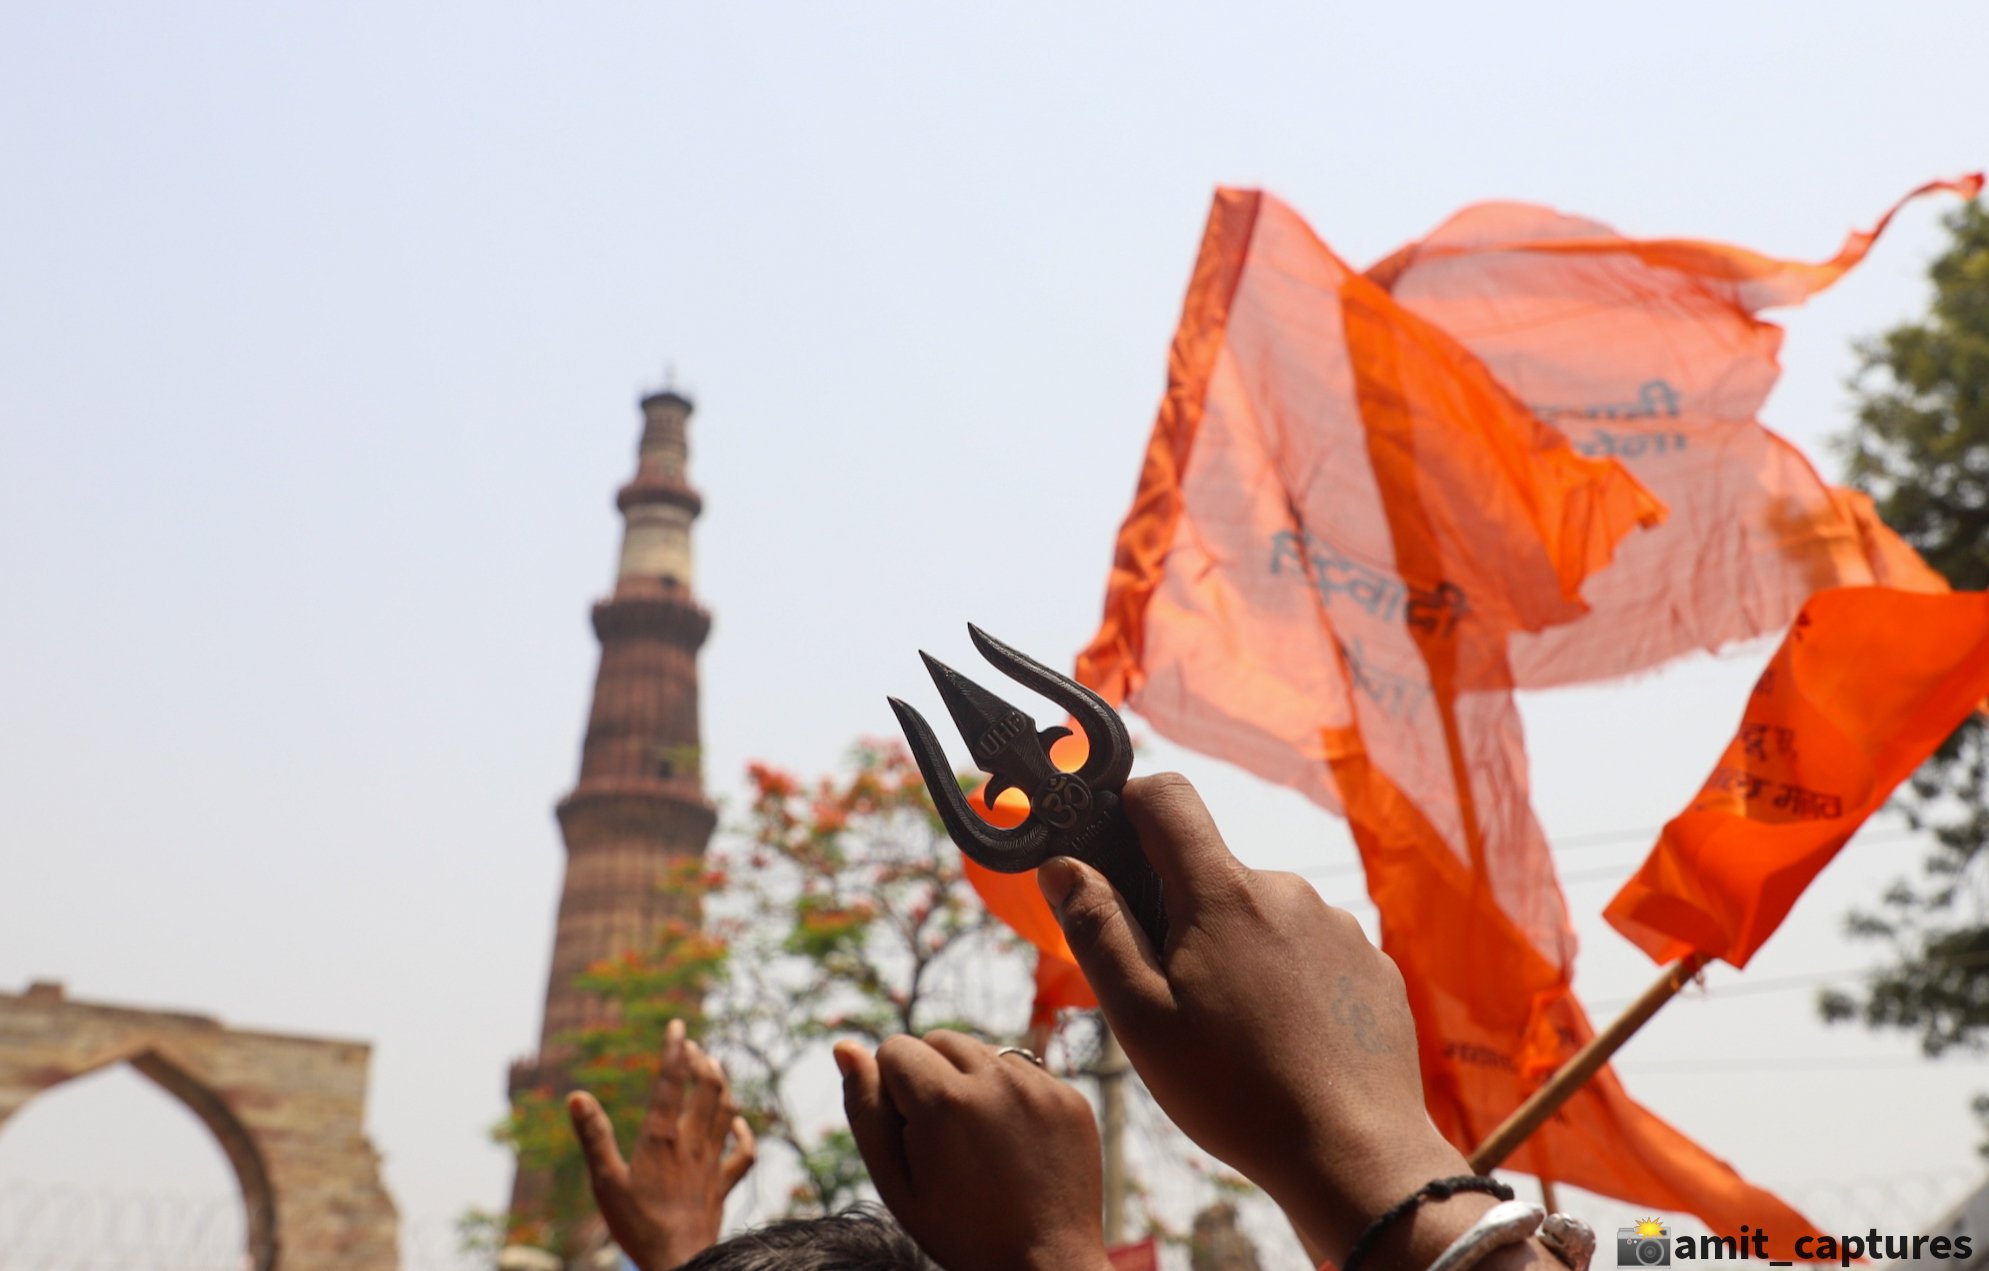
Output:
top-left (1036, 774), bottom-right (1519, 1265)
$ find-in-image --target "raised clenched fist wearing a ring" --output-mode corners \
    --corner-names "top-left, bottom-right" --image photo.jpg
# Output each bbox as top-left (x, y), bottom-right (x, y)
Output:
top-left (835, 1032), bottom-right (1106, 1271)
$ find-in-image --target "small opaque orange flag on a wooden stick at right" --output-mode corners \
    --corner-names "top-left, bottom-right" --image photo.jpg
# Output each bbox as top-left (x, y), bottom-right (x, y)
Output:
top-left (1603, 587), bottom-right (1989, 967)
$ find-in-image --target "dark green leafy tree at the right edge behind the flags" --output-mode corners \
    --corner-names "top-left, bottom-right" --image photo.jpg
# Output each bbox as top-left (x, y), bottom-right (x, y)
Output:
top-left (1822, 203), bottom-right (1989, 1097)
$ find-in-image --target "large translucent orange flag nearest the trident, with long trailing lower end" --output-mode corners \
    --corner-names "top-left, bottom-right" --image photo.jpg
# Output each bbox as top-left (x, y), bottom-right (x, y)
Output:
top-left (1078, 191), bottom-right (1808, 1257)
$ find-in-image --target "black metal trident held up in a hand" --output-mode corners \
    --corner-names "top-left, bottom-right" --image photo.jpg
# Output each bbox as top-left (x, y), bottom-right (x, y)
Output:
top-left (891, 623), bottom-right (1168, 951)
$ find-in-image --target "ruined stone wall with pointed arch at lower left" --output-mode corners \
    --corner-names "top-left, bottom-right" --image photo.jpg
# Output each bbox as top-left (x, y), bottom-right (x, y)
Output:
top-left (0, 983), bottom-right (400, 1271)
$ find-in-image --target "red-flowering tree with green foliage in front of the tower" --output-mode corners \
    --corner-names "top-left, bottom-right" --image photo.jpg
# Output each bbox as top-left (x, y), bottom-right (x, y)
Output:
top-left (497, 744), bottom-right (1028, 1257)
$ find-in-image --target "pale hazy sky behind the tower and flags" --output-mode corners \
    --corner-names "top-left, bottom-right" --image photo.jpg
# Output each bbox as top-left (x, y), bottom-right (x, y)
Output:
top-left (0, 0), bottom-right (1989, 1265)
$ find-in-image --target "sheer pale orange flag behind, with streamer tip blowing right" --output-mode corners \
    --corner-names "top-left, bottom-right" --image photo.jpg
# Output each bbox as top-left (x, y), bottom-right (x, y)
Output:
top-left (1366, 175), bottom-right (1981, 686)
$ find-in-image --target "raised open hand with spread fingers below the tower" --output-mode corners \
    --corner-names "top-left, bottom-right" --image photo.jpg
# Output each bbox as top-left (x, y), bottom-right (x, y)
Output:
top-left (567, 1020), bottom-right (756, 1271)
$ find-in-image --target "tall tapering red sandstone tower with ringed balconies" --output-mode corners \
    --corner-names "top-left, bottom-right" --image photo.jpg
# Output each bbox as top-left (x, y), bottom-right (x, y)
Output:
top-left (511, 388), bottom-right (718, 1211)
